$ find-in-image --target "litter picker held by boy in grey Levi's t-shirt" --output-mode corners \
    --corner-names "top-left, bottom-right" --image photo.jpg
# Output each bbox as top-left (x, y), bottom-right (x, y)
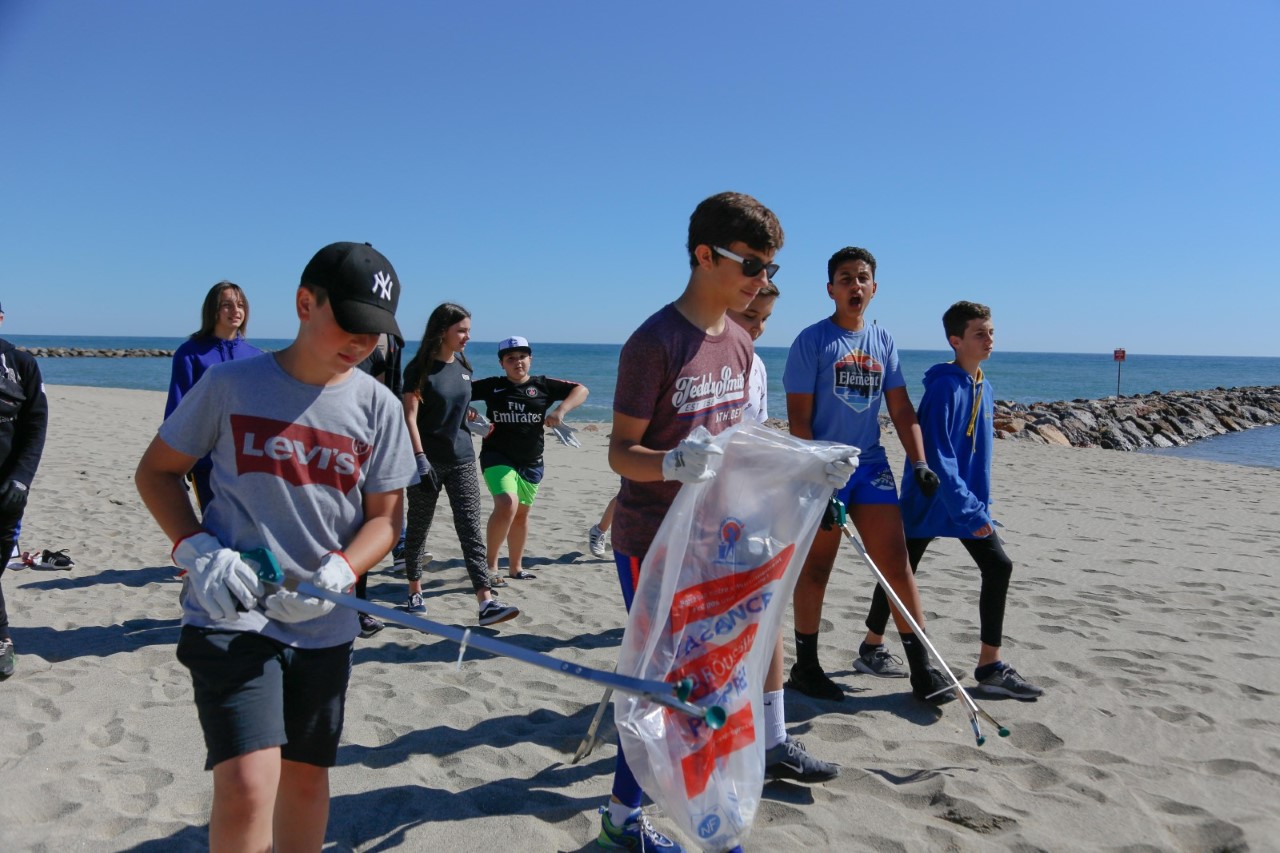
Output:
top-left (241, 548), bottom-right (724, 730)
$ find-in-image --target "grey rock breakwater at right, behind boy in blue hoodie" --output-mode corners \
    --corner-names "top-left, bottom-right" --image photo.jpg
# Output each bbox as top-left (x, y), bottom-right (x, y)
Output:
top-left (995, 386), bottom-right (1280, 451)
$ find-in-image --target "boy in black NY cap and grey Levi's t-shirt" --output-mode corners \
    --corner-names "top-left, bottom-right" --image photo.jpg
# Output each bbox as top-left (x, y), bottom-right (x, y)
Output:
top-left (134, 243), bottom-right (415, 849)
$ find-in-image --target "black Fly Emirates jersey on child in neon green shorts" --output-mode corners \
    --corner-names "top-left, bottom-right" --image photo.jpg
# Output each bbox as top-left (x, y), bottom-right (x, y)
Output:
top-left (471, 377), bottom-right (577, 467)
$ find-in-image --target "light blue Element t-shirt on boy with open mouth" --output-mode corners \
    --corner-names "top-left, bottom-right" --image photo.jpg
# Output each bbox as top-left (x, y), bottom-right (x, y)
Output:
top-left (782, 318), bottom-right (906, 462)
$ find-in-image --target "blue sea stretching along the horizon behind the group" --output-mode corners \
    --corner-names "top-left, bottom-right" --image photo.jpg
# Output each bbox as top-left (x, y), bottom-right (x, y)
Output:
top-left (5, 334), bottom-right (1280, 469)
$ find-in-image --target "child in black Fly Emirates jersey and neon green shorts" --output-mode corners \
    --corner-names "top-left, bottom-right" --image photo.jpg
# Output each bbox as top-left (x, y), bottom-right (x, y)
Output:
top-left (471, 336), bottom-right (589, 580)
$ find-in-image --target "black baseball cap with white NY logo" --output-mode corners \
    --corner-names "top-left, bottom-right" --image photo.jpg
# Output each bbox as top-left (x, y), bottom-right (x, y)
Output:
top-left (302, 243), bottom-right (404, 346)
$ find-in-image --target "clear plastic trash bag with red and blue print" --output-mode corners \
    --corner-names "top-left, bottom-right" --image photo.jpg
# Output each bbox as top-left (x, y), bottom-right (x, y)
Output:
top-left (613, 423), bottom-right (832, 853)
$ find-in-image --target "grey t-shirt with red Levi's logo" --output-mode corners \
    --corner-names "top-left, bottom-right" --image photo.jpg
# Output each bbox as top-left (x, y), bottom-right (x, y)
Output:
top-left (160, 355), bottom-right (417, 648)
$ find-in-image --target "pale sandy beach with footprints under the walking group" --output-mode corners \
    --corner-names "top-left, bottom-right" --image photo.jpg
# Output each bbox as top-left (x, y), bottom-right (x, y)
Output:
top-left (0, 387), bottom-right (1280, 852)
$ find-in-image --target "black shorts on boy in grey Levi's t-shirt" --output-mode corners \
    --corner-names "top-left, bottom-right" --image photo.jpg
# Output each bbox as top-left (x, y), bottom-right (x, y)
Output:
top-left (178, 625), bottom-right (353, 770)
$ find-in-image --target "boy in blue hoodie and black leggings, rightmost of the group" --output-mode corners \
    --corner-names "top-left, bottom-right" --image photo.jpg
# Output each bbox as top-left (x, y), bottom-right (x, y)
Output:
top-left (885, 302), bottom-right (1043, 699)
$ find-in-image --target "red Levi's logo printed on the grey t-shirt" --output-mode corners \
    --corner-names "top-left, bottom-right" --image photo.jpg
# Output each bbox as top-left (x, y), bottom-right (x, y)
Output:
top-left (230, 415), bottom-right (372, 494)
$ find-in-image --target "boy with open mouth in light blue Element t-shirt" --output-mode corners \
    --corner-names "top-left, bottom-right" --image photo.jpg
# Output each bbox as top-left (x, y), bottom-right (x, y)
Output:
top-left (782, 246), bottom-right (956, 704)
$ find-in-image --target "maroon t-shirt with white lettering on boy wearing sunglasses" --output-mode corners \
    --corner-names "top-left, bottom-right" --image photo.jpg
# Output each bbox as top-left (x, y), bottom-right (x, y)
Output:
top-left (613, 305), bottom-right (751, 557)
